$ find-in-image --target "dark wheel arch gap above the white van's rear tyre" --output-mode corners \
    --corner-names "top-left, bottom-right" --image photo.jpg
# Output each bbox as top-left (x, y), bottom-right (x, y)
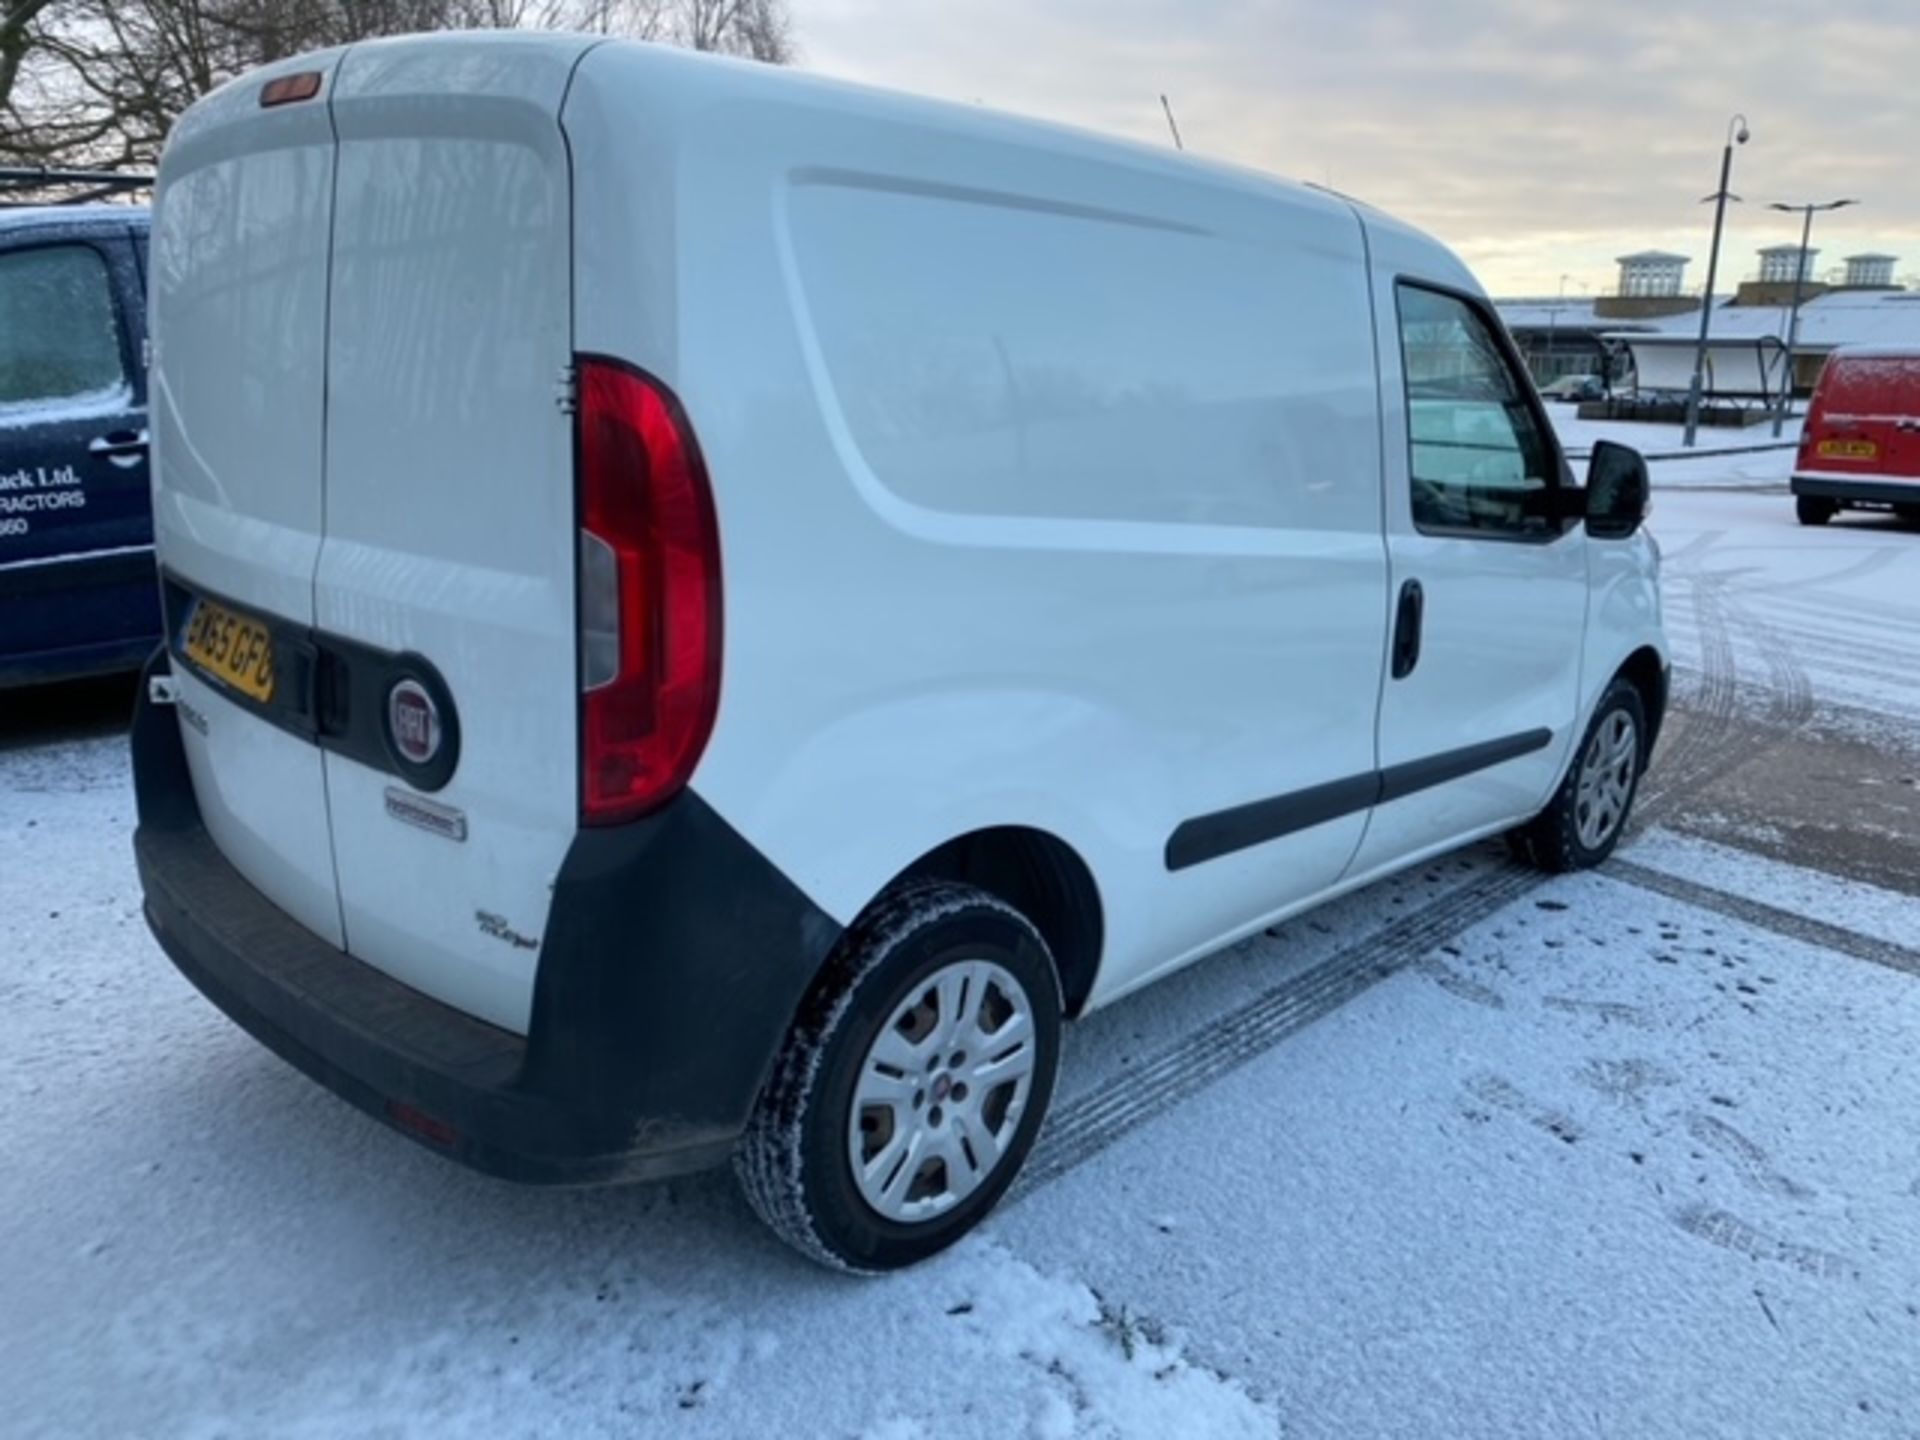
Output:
top-left (883, 826), bottom-right (1106, 1018)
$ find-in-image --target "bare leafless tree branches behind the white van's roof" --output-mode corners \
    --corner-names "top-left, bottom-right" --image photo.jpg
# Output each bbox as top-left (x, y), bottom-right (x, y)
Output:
top-left (0, 0), bottom-right (793, 167)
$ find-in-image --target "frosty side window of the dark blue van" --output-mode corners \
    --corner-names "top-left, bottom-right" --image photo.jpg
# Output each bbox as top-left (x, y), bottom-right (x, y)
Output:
top-left (0, 246), bottom-right (127, 420)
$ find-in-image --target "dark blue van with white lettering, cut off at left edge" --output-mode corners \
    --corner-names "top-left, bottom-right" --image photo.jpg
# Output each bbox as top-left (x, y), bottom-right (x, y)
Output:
top-left (0, 205), bottom-right (159, 687)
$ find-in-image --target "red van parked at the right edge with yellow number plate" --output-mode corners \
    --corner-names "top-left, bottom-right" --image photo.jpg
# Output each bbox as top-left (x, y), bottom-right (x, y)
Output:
top-left (1793, 346), bottom-right (1920, 524)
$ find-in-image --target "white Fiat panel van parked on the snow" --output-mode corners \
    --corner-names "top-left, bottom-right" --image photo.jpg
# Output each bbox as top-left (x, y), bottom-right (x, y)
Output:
top-left (132, 35), bottom-right (1667, 1271)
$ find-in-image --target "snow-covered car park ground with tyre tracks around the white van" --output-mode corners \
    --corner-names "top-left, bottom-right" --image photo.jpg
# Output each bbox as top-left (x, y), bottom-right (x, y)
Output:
top-left (0, 487), bottom-right (1920, 1440)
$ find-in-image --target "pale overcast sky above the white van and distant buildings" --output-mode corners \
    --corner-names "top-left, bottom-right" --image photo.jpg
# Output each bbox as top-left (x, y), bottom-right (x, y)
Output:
top-left (793, 0), bottom-right (1920, 294)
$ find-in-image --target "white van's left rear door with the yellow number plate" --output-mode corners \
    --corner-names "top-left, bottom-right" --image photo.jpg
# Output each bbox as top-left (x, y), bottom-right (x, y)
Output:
top-left (148, 52), bottom-right (340, 945)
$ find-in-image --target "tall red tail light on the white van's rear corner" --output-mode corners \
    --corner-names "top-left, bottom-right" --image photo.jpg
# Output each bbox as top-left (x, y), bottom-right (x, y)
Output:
top-left (578, 357), bottom-right (720, 826)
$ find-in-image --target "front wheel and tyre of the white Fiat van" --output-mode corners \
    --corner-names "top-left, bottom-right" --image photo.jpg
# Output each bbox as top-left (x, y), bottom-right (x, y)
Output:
top-left (1507, 678), bottom-right (1647, 874)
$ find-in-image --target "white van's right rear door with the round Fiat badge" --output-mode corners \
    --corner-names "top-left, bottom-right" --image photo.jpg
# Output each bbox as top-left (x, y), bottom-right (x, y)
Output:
top-left (315, 35), bottom-right (589, 1031)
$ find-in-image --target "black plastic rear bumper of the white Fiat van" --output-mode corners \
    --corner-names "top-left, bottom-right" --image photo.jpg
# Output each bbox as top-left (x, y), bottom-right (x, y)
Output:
top-left (132, 657), bottom-right (839, 1185)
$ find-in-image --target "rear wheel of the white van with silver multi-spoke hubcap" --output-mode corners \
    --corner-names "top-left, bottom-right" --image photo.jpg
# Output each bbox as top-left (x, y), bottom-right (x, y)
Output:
top-left (735, 881), bottom-right (1060, 1273)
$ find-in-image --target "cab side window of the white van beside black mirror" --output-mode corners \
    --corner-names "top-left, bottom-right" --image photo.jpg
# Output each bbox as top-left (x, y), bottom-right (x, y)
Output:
top-left (1398, 284), bottom-right (1559, 538)
